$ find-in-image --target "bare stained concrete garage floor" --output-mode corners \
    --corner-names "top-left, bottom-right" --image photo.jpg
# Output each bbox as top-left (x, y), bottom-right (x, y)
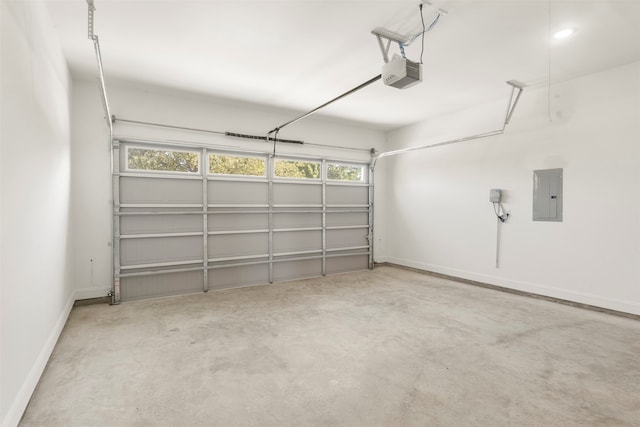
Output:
top-left (21, 267), bottom-right (640, 427)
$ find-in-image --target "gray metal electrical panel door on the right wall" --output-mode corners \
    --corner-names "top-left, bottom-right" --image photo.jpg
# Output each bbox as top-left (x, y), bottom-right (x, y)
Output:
top-left (533, 169), bottom-right (562, 222)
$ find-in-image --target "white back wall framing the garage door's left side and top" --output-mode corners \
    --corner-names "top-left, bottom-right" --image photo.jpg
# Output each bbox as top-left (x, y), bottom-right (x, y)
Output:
top-left (71, 75), bottom-right (385, 298)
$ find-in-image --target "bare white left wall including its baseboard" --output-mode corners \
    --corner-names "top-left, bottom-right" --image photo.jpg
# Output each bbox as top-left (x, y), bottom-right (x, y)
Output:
top-left (0, 1), bottom-right (74, 426)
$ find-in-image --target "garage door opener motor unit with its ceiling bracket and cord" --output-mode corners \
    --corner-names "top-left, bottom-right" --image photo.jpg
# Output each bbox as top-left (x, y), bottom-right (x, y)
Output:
top-left (371, 1), bottom-right (447, 89)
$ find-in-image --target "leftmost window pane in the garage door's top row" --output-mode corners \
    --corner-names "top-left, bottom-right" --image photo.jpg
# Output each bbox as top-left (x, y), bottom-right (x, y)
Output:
top-left (127, 147), bottom-right (200, 173)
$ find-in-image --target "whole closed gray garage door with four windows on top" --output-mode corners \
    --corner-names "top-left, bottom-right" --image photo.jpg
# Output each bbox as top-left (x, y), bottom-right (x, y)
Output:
top-left (113, 141), bottom-right (371, 301)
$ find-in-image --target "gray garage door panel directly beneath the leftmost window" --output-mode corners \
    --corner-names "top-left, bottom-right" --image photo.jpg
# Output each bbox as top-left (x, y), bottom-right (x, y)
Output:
top-left (120, 177), bottom-right (202, 204)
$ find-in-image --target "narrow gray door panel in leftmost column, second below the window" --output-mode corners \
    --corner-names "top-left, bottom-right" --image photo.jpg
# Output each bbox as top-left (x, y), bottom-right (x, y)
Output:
top-left (120, 215), bottom-right (202, 235)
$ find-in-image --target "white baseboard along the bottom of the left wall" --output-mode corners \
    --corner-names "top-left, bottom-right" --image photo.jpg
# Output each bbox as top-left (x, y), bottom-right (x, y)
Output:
top-left (2, 292), bottom-right (76, 427)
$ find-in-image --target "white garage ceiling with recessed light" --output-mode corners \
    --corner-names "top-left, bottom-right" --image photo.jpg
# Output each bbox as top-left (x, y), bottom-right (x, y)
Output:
top-left (48, 0), bottom-right (640, 129)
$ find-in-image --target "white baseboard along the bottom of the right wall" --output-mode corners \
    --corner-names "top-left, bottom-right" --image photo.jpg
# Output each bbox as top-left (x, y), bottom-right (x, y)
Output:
top-left (376, 257), bottom-right (640, 315)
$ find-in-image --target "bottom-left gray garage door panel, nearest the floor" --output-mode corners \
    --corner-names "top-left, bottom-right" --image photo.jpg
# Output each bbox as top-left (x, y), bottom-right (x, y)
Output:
top-left (120, 271), bottom-right (203, 301)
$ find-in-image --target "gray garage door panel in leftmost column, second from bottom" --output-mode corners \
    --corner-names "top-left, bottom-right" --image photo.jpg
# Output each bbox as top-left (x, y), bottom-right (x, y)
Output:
top-left (120, 236), bottom-right (202, 266)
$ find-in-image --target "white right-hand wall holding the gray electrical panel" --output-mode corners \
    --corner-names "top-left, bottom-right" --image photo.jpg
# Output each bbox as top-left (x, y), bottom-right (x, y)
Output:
top-left (377, 63), bottom-right (640, 314)
